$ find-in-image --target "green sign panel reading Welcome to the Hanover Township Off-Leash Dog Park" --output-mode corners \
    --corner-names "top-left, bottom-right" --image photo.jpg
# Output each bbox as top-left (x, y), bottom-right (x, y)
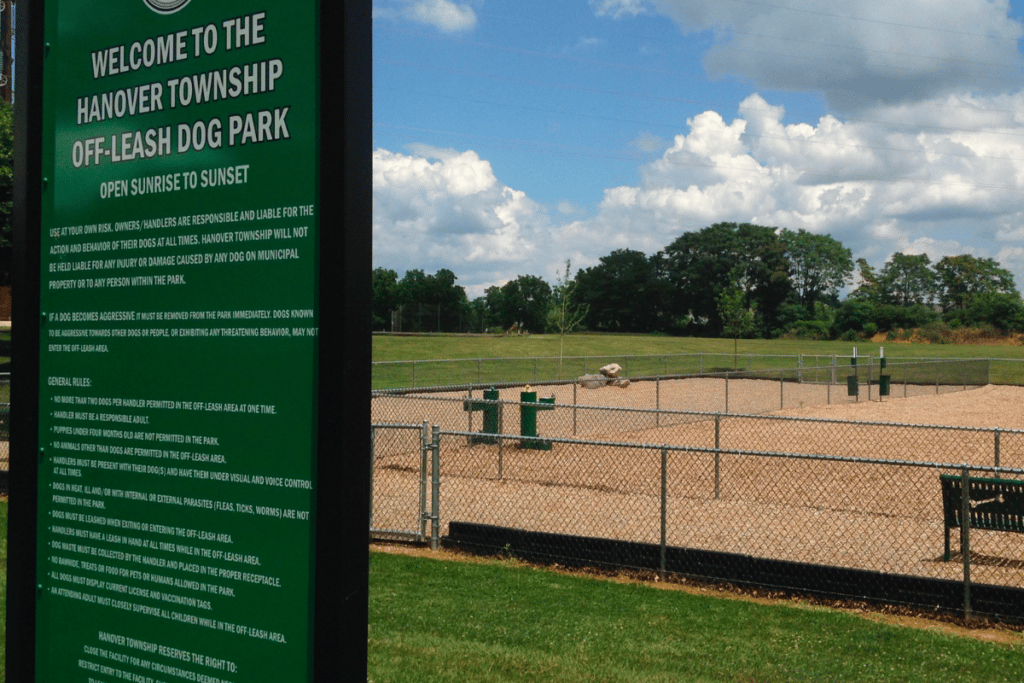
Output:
top-left (36, 0), bottom-right (319, 683)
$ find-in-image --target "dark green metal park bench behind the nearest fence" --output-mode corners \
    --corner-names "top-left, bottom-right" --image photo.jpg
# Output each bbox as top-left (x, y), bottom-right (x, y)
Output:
top-left (939, 474), bottom-right (1024, 562)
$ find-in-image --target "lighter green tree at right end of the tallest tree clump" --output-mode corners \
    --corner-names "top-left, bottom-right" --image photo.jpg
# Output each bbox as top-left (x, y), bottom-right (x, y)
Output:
top-left (779, 228), bottom-right (853, 316)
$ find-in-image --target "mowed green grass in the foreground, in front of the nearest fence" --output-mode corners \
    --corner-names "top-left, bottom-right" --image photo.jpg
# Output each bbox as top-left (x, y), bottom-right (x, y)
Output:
top-left (367, 552), bottom-right (1024, 683)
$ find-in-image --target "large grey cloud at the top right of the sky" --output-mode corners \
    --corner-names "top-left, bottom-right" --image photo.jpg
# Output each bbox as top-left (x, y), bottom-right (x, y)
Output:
top-left (638, 0), bottom-right (1024, 111)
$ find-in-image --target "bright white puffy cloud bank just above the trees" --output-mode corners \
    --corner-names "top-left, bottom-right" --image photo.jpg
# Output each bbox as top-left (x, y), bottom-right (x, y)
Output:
top-left (374, 95), bottom-right (1024, 296)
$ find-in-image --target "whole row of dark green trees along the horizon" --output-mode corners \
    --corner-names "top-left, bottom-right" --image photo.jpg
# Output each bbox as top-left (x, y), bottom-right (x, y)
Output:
top-left (373, 223), bottom-right (1024, 340)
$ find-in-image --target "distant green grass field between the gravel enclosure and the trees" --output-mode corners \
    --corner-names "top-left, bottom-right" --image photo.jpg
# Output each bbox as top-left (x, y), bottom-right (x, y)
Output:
top-left (373, 334), bottom-right (1024, 389)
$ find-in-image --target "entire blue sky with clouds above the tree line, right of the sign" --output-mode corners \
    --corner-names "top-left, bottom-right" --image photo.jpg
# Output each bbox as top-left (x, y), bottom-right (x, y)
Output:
top-left (373, 0), bottom-right (1024, 298)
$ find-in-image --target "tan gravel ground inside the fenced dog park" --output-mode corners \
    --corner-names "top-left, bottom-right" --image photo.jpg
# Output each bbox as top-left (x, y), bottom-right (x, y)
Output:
top-left (374, 379), bottom-right (1024, 598)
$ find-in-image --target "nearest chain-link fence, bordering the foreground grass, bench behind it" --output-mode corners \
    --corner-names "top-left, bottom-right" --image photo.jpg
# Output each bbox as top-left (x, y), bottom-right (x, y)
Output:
top-left (373, 425), bottom-right (1024, 620)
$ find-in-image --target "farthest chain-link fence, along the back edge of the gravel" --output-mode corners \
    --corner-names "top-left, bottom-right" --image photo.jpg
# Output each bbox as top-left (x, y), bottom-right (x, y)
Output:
top-left (373, 353), bottom-right (1024, 390)
